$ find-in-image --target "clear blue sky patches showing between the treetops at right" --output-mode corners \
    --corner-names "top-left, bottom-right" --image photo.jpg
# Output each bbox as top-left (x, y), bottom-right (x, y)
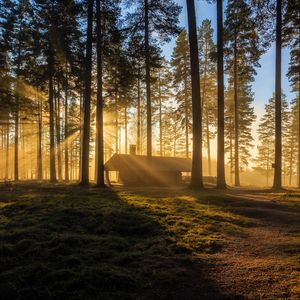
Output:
top-left (163, 0), bottom-right (294, 163)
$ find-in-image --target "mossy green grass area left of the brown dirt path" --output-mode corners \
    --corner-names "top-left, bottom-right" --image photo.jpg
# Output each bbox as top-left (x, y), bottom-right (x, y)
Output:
top-left (0, 184), bottom-right (298, 299)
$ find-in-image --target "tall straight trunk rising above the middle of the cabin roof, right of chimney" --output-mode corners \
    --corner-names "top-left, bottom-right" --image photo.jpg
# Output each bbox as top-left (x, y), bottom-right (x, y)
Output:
top-left (144, 0), bottom-right (152, 157)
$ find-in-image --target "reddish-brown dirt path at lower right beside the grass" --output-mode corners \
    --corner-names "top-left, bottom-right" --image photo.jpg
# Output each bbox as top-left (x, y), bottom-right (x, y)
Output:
top-left (210, 194), bottom-right (300, 299)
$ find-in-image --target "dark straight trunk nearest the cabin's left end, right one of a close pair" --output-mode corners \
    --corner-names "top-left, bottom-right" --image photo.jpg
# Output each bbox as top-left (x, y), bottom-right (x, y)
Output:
top-left (96, 0), bottom-right (104, 187)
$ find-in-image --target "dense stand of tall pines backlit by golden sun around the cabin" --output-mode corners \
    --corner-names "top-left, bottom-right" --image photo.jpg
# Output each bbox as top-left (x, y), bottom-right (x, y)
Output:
top-left (0, 0), bottom-right (300, 187)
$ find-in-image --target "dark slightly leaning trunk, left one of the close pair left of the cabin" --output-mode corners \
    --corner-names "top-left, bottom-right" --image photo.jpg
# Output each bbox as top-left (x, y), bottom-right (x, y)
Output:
top-left (81, 0), bottom-right (94, 185)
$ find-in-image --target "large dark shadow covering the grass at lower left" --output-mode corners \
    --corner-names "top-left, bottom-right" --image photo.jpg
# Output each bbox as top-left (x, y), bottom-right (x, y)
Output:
top-left (0, 186), bottom-right (224, 299)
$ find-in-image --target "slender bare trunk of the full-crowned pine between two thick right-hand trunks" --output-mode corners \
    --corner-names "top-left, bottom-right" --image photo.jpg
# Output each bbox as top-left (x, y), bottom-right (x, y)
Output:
top-left (234, 37), bottom-right (240, 187)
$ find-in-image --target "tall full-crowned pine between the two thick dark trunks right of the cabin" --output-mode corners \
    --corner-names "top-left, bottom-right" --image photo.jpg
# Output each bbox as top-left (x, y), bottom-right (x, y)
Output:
top-left (225, 0), bottom-right (264, 186)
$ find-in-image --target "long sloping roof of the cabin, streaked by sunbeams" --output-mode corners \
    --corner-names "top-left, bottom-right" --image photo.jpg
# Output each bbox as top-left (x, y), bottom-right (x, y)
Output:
top-left (105, 154), bottom-right (192, 172)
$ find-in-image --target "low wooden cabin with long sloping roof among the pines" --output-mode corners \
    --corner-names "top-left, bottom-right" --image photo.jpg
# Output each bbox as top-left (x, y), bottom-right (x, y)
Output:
top-left (105, 154), bottom-right (192, 186)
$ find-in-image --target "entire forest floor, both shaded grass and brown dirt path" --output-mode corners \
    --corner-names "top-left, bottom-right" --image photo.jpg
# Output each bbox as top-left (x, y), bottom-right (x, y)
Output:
top-left (0, 183), bottom-right (300, 300)
